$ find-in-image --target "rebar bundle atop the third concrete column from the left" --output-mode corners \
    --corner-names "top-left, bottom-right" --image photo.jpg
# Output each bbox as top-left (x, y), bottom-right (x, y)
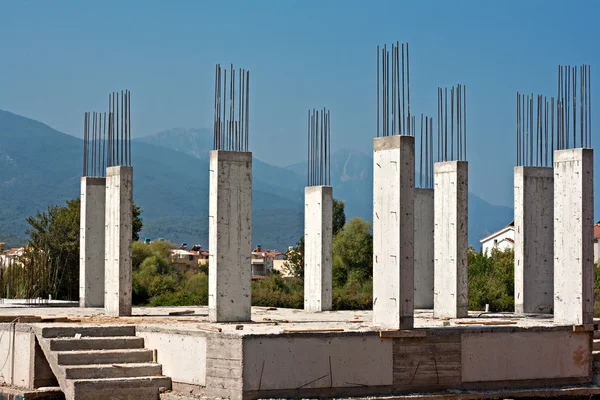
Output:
top-left (213, 64), bottom-right (250, 151)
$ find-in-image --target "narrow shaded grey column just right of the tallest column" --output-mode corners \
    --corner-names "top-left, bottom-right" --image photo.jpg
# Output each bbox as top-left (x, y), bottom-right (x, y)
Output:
top-left (415, 189), bottom-right (434, 309)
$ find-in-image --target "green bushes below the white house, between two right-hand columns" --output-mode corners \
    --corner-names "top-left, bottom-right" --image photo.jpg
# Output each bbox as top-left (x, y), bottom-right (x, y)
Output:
top-left (468, 249), bottom-right (515, 311)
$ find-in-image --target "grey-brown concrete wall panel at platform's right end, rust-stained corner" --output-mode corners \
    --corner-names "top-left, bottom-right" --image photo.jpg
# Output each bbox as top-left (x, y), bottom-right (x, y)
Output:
top-left (461, 331), bottom-right (591, 382)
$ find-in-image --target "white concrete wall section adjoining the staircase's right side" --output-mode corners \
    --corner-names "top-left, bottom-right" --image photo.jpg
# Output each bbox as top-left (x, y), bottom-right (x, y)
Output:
top-left (136, 328), bottom-right (206, 386)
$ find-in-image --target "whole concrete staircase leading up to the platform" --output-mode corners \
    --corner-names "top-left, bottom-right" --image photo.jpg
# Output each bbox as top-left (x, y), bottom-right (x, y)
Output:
top-left (36, 325), bottom-right (171, 400)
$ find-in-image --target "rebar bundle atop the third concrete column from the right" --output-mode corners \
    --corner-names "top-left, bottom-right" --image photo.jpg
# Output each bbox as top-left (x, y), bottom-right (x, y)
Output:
top-left (437, 84), bottom-right (467, 161)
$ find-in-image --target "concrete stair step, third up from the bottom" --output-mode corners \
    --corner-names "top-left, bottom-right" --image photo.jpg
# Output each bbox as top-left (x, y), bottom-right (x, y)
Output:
top-left (56, 349), bottom-right (153, 365)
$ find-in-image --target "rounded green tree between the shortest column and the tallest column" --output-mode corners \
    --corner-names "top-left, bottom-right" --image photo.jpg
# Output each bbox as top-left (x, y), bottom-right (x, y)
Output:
top-left (333, 217), bottom-right (373, 286)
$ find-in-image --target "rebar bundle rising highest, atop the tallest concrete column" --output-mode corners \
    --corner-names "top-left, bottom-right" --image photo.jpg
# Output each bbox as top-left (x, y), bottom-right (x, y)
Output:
top-left (377, 42), bottom-right (414, 137)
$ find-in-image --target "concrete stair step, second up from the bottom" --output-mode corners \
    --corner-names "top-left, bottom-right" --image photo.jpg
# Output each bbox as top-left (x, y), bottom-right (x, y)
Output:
top-left (64, 363), bottom-right (162, 379)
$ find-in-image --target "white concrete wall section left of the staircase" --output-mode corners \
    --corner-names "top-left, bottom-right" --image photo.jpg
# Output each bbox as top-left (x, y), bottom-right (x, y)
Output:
top-left (0, 324), bottom-right (35, 389)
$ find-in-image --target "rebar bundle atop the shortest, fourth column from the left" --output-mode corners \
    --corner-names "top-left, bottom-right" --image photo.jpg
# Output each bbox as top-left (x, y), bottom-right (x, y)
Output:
top-left (308, 108), bottom-right (331, 186)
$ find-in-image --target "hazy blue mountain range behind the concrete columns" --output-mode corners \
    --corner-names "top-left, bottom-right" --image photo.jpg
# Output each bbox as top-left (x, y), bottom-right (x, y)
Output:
top-left (0, 110), bottom-right (512, 250)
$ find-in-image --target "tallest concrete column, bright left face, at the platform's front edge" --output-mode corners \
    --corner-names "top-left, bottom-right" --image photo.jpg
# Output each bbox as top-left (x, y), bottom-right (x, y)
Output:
top-left (373, 136), bottom-right (415, 329)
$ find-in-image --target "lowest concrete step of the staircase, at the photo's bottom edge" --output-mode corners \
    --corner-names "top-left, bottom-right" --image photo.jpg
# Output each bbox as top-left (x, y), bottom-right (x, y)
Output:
top-left (72, 376), bottom-right (171, 400)
